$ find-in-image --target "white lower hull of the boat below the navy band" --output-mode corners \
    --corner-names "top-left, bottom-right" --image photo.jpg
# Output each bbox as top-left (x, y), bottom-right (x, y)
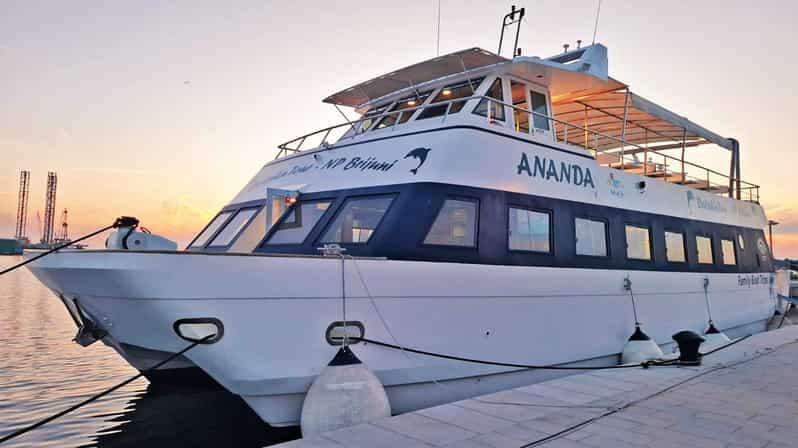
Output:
top-left (30, 251), bottom-right (775, 425)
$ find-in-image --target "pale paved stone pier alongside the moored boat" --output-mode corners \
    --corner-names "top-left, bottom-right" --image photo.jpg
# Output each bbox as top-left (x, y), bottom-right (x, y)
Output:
top-left (278, 327), bottom-right (798, 448)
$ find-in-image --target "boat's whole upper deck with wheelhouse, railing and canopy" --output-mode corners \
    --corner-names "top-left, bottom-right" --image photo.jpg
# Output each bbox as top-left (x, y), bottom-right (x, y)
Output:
top-left (277, 44), bottom-right (759, 202)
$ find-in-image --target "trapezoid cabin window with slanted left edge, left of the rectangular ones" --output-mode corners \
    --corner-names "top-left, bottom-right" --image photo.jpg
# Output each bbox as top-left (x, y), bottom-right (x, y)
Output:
top-left (424, 199), bottom-right (479, 247)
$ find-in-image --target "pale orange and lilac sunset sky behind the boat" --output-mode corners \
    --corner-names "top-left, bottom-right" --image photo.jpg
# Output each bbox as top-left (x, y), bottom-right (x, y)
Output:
top-left (0, 0), bottom-right (798, 257)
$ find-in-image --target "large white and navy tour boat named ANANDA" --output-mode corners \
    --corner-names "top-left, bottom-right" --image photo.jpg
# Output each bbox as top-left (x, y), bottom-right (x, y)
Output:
top-left (29, 25), bottom-right (776, 426)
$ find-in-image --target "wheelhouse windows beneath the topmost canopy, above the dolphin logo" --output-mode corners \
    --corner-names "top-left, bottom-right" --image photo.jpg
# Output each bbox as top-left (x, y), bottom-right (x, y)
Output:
top-left (358, 77), bottom-right (550, 134)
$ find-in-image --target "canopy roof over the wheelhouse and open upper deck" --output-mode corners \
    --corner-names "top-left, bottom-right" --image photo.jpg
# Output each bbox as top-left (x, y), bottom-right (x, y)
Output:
top-left (324, 44), bottom-right (733, 153)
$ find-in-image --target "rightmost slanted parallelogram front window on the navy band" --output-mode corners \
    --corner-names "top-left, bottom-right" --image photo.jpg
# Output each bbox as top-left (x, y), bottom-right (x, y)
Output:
top-left (321, 196), bottom-right (394, 243)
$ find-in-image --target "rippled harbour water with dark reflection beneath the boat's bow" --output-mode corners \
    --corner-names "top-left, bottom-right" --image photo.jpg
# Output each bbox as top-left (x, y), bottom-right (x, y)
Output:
top-left (0, 256), bottom-right (299, 448)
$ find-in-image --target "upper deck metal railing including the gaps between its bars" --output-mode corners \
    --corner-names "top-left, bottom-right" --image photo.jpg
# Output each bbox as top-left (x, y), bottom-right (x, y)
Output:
top-left (275, 95), bottom-right (759, 202)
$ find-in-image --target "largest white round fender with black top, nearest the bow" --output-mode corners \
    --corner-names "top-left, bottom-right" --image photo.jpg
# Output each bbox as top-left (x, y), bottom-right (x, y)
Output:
top-left (300, 346), bottom-right (391, 437)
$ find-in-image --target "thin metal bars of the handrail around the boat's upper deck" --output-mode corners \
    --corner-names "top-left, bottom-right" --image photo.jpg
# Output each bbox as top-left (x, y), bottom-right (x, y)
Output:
top-left (275, 95), bottom-right (759, 202)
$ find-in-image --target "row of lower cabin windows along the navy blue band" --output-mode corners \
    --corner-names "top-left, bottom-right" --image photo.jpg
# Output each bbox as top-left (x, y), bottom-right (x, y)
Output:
top-left (191, 195), bottom-right (744, 266)
